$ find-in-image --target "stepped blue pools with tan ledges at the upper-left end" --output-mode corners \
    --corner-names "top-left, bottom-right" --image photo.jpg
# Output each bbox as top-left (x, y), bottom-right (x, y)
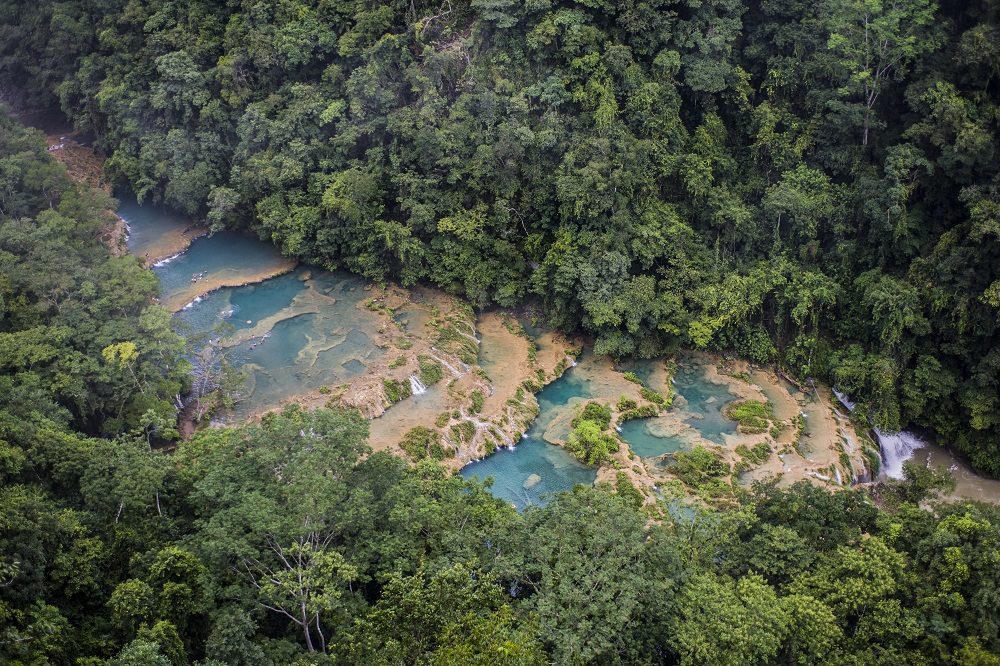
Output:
top-left (120, 195), bottom-right (384, 419)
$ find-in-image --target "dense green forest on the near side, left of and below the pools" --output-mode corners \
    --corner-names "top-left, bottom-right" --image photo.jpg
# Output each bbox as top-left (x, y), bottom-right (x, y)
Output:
top-left (0, 116), bottom-right (1000, 666)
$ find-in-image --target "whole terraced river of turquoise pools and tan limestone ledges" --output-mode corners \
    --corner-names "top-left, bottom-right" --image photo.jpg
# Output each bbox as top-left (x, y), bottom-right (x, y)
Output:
top-left (119, 195), bottom-right (1000, 509)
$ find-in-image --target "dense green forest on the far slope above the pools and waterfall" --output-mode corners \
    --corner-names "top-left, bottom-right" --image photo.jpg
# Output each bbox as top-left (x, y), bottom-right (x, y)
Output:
top-left (0, 0), bottom-right (1000, 475)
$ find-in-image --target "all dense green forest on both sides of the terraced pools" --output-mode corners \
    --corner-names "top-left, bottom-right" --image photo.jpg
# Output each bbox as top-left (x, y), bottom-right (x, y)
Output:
top-left (0, 0), bottom-right (1000, 666)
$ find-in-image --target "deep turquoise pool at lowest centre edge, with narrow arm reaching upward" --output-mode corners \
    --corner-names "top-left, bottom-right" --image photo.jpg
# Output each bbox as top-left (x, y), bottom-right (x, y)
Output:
top-left (461, 369), bottom-right (597, 510)
